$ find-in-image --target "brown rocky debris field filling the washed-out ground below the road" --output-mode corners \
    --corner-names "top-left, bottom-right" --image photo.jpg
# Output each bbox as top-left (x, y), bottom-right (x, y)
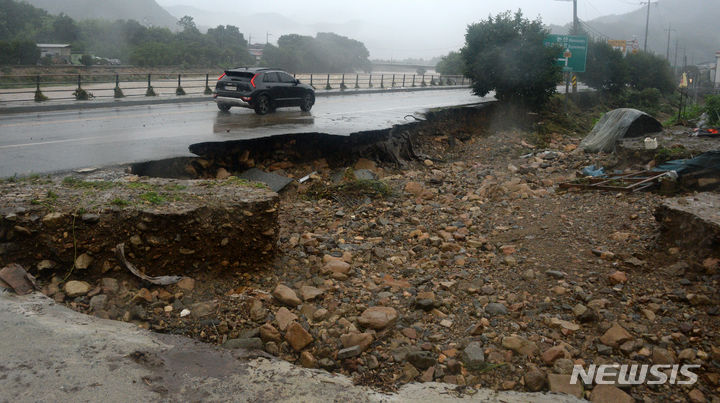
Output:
top-left (2, 107), bottom-right (720, 402)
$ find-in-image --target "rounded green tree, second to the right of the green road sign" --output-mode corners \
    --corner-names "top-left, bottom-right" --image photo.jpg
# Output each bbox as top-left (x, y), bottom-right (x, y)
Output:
top-left (626, 52), bottom-right (676, 94)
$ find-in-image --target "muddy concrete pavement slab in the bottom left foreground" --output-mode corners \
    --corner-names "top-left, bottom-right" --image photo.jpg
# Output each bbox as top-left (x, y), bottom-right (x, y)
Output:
top-left (0, 290), bottom-right (578, 403)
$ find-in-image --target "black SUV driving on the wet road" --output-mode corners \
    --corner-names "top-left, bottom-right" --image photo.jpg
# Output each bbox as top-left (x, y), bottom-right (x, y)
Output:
top-left (213, 67), bottom-right (315, 115)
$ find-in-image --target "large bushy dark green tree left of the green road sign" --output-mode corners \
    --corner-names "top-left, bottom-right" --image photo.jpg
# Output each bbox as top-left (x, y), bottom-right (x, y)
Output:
top-left (460, 11), bottom-right (562, 109)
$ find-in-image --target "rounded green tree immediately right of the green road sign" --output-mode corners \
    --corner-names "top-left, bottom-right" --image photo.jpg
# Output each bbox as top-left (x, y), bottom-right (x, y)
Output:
top-left (579, 41), bottom-right (629, 94)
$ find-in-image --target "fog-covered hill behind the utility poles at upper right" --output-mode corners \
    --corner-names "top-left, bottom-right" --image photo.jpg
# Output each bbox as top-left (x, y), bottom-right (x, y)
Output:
top-left (550, 0), bottom-right (720, 65)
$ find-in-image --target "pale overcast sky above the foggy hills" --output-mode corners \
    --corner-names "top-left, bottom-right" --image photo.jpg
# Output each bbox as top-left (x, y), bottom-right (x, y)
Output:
top-left (156, 0), bottom-right (641, 59)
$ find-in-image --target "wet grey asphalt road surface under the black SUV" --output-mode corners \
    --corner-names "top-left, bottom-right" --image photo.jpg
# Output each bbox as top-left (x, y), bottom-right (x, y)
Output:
top-left (0, 89), bottom-right (489, 178)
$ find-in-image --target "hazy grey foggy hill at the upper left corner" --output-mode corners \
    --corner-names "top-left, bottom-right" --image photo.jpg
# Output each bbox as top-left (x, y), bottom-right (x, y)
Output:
top-left (24, 0), bottom-right (177, 29)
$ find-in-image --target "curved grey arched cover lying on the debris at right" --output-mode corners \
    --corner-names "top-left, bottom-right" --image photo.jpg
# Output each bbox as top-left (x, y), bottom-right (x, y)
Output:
top-left (580, 108), bottom-right (662, 153)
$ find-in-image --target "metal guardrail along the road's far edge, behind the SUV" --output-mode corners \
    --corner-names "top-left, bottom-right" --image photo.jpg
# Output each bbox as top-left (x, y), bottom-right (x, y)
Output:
top-left (0, 73), bottom-right (470, 104)
